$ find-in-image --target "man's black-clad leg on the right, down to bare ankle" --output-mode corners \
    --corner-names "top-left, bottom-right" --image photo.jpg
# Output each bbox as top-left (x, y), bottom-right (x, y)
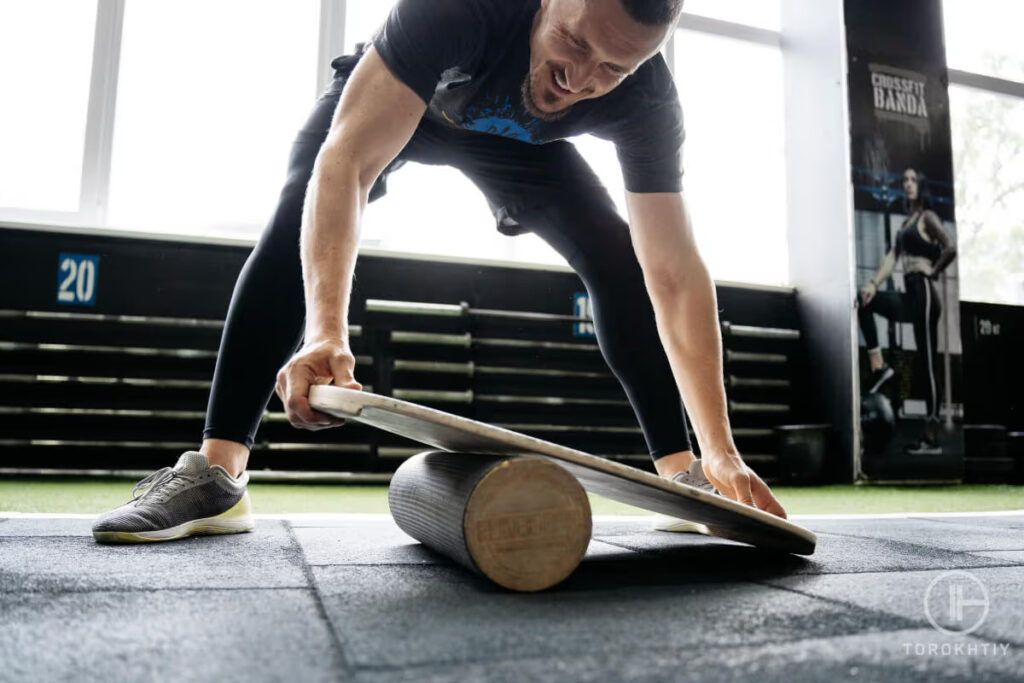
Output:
top-left (458, 141), bottom-right (694, 477)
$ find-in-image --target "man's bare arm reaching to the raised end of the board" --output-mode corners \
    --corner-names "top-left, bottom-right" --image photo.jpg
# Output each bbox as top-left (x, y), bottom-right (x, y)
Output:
top-left (278, 48), bottom-right (426, 429)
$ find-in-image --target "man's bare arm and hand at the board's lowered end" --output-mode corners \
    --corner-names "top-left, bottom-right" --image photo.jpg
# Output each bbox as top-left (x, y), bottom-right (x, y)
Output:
top-left (627, 193), bottom-right (785, 516)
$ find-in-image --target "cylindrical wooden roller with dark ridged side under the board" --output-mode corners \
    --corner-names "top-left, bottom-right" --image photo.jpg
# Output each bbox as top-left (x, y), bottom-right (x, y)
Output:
top-left (388, 451), bottom-right (592, 591)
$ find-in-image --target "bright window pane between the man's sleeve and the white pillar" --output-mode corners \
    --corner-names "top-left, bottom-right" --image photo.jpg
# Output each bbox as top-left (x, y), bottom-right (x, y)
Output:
top-left (675, 30), bottom-right (788, 285)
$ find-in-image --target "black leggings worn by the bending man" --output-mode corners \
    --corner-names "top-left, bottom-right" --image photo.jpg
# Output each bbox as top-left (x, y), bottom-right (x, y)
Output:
top-left (204, 57), bottom-right (690, 459)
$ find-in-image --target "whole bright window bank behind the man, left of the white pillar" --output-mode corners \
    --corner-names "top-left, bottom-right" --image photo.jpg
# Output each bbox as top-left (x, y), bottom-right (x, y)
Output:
top-left (0, 0), bottom-right (786, 284)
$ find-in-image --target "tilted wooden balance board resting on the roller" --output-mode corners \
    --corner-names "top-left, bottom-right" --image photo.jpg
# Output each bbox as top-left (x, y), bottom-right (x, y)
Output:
top-left (309, 385), bottom-right (817, 555)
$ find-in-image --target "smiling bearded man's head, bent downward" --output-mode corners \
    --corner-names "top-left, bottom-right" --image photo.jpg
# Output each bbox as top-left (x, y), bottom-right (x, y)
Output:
top-left (522, 0), bottom-right (683, 121)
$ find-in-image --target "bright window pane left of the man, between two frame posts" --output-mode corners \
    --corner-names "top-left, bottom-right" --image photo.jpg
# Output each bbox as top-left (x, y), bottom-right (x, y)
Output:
top-left (108, 0), bottom-right (318, 237)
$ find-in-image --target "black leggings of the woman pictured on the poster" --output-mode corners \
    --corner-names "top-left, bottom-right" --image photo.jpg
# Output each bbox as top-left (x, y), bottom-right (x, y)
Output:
top-left (857, 272), bottom-right (942, 419)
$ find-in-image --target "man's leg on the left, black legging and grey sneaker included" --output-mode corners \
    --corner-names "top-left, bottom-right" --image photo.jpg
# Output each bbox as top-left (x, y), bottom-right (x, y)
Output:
top-left (92, 57), bottom-right (417, 543)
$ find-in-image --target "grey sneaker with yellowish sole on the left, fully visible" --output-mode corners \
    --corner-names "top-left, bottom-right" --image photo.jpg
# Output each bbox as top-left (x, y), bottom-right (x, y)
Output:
top-left (92, 451), bottom-right (256, 543)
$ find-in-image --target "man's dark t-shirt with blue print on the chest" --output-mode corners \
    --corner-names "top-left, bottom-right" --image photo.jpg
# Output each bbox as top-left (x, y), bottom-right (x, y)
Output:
top-left (356, 0), bottom-right (683, 193)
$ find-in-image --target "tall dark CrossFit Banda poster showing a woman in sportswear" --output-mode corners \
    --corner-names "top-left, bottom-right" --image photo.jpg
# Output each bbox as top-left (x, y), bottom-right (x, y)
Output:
top-left (845, 0), bottom-right (964, 481)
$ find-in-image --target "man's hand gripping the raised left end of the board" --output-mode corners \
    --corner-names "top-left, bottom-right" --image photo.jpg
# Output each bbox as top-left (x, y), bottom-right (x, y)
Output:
top-left (274, 339), bottom-right (362, 431)
